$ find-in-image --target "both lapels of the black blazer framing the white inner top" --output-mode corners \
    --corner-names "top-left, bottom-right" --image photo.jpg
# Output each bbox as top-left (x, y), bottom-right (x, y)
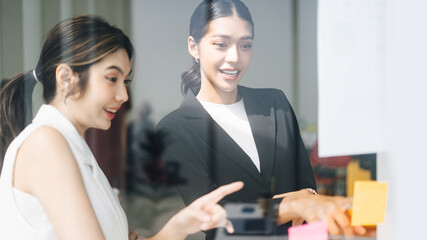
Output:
top-left (180, 86), bottom-right (276, 186)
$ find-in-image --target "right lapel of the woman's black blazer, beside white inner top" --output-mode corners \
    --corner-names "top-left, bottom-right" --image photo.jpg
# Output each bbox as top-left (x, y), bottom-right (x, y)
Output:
top-left (239, 87), bottom-right (276, 189)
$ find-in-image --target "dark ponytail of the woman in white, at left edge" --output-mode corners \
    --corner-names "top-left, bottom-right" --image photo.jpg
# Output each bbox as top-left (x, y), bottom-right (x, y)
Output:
top-left (0, 71), bottom-right (37, 158)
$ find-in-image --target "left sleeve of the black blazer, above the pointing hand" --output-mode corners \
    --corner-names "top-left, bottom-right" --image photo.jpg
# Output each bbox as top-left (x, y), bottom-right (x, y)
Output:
top-left (156, 122), bottom-right (217, 205)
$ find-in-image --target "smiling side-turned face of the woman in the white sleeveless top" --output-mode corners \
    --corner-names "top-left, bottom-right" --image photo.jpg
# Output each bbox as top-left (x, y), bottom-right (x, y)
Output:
top-left (67, 49), bottom-right (131, 135)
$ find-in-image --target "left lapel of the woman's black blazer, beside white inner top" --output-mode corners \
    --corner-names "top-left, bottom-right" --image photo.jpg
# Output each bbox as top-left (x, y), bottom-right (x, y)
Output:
top-left (181, 91), bottom-right (265, 186)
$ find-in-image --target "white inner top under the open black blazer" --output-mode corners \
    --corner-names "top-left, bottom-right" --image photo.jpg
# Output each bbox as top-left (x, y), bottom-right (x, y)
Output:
top-left (199, 98), bottom-right (261, 172)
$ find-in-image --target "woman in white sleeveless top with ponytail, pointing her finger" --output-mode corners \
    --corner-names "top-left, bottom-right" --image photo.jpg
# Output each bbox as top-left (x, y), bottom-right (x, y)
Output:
top-left (0, 15), bottom-right (243, 240)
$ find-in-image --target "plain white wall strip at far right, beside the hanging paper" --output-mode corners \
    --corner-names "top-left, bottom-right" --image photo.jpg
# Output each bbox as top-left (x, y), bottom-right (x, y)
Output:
top-left (378, 0), bottom-right (427, 239)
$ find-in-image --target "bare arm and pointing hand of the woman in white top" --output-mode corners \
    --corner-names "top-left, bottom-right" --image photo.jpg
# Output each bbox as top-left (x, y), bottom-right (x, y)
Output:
top-left (13, 127), bottom-right (243, 240)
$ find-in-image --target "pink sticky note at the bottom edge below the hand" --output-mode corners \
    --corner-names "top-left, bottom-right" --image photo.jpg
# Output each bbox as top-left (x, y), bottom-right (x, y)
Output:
top-left (288, 222), bottom-right (328, 240)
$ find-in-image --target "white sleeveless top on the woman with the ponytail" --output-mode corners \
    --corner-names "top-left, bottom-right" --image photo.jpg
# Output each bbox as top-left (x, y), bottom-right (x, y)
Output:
top-left (0, 105), bottom-right (128, 240)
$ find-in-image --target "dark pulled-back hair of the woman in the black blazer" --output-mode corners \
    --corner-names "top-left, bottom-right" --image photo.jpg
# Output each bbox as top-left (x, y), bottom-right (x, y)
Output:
top-left (181, 0), bottom-right (254, 94)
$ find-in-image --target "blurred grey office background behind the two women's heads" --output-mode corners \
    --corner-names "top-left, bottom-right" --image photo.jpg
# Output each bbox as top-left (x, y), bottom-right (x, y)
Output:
top-left (0, 0), bottom-right (317, 125)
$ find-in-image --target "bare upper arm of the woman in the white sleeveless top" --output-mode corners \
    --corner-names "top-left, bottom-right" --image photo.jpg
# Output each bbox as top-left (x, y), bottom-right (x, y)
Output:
top-left (14, 127), bottom-right (105, 240)
